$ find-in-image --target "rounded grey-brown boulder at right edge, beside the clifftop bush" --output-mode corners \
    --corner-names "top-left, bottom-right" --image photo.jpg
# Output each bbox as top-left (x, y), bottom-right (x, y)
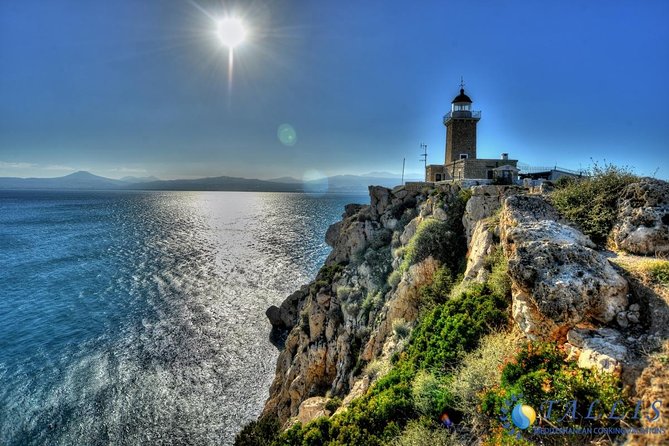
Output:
top-left (613, 178), bottom-right (669, 255)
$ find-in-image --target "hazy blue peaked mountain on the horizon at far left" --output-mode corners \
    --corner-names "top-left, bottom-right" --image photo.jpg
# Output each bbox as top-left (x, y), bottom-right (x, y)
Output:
top-left (0, 170), bottom-right (128, 190)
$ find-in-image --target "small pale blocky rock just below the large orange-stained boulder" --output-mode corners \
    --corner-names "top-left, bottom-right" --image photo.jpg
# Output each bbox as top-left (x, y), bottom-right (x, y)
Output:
top-left (567, 328), bottom-right (628, 373)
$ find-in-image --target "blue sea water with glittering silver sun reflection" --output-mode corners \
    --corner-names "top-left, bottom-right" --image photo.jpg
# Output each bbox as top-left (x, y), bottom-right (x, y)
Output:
top-left (0, 191), bottom-right (368, 445)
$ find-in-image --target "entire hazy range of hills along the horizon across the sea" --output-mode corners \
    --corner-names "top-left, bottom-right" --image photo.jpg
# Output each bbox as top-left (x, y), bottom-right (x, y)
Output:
top-left (0, 171), bottom-right (418, 193)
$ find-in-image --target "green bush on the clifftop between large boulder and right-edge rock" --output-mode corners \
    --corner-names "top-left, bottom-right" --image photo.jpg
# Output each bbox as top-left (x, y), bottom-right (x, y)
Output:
top-left (551, 164), bottom-right (638, 245)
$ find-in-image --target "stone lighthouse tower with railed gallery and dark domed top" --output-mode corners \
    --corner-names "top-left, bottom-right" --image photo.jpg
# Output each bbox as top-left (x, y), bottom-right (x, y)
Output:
top-left (444, 85), bottom-right (481, 164)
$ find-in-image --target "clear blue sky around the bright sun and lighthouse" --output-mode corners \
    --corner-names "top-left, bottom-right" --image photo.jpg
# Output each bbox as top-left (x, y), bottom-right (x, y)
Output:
top-left (0, 0), bottom-right (669, 179)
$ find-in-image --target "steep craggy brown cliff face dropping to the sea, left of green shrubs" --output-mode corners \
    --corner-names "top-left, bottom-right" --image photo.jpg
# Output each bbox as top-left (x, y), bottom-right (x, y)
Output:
top-left (264, 187), bottom-right (443, 423)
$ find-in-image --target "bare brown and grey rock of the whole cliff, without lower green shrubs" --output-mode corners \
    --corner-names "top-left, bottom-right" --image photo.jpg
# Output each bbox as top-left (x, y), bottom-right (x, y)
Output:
top-left (250, 179), bottom-right (669, 444)
